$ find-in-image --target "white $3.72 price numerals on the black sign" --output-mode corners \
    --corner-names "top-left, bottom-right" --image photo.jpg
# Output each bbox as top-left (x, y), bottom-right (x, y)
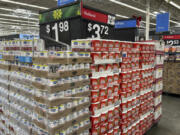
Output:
top-left (87, 23), bottom-right (109, 38)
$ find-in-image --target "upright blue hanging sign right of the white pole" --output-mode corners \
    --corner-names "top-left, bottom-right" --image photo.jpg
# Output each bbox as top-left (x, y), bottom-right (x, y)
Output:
top-left (156, 13), bottom-right (169, 32)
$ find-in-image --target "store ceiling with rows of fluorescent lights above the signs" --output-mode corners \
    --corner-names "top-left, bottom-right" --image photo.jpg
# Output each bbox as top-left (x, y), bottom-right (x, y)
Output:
top-left (0, 0), bottom-right (180, 32)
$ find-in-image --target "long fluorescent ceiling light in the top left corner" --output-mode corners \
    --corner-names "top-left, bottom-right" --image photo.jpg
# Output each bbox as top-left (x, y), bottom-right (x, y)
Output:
top-left (0, 0), bottom-right (49, 9)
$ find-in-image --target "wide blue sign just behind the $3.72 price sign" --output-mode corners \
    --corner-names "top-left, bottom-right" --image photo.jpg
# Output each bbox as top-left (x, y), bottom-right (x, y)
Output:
top-left (115, 19), bottom-right (136, 29)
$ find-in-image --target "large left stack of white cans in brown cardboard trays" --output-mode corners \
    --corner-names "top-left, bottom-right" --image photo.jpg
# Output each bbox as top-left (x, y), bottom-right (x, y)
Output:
top-left (0, 40), bottom-right (91, 135)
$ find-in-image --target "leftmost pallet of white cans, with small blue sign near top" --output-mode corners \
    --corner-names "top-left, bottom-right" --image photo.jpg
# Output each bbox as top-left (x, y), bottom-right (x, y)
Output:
top-left (0, 40), bottom-right (43, 135)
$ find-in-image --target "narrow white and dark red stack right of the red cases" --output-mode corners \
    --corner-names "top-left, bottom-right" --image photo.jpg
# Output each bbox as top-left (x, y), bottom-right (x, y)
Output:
top-left (154, 41), bottom-right (164, 123)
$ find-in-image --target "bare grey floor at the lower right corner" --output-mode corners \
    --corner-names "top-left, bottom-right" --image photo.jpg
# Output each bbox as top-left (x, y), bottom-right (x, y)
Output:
top-left (147, 95), bottom-right (180, 135)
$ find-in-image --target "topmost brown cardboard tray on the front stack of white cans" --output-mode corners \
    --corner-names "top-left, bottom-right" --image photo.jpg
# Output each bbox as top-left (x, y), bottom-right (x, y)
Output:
top-left (33, 57), bottom-right (92, 64)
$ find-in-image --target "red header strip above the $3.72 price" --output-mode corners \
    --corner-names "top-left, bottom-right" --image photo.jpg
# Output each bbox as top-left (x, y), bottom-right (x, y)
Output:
top-left (81, 8), bottom-right (115, 25)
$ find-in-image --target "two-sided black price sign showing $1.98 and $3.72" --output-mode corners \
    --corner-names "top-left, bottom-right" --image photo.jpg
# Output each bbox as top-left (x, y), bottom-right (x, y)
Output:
top-left (40, 2), bottom-right (115, 49)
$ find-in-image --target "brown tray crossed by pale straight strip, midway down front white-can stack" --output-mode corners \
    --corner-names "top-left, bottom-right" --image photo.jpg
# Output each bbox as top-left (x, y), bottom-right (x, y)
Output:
top-left (34, 91), bottom-right (91, 107)
